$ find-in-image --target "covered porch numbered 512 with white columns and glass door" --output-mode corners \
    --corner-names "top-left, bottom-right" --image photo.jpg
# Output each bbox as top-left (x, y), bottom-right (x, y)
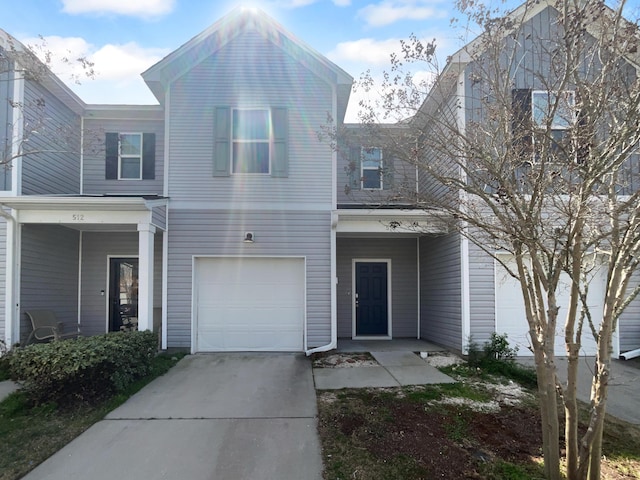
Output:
top-left (0, 196), bottom-right (167, 344)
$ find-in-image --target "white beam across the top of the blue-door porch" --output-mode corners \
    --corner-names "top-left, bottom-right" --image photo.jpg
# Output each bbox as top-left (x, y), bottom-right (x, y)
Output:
top-left (334, 209), bottom-right (449, 236)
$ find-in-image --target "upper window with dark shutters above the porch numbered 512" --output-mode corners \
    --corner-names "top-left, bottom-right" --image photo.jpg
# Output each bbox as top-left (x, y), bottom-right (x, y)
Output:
top-left (105, 133), bottom-right (156, 180)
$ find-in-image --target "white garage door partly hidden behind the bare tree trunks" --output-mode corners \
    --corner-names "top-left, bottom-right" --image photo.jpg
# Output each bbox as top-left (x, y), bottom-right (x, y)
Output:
top-left (496, 255), bottom-right (605, 357)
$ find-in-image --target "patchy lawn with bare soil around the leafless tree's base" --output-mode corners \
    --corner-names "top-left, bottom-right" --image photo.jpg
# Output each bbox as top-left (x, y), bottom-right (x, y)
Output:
top-left (318, 354), bottom-right (640, 480)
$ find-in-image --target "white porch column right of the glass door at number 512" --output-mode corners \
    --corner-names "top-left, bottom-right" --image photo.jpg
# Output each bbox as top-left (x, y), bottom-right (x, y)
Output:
top-left (138, 223), bottom-right (156, 331)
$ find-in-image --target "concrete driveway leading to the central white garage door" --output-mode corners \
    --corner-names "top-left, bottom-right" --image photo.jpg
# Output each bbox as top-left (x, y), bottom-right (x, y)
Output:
top-left (24, 353), bottom-right (322, 480)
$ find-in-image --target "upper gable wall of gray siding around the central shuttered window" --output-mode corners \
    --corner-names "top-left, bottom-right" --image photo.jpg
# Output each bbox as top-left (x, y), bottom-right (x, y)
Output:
top-left (169, 32), bottom-right (333, 205)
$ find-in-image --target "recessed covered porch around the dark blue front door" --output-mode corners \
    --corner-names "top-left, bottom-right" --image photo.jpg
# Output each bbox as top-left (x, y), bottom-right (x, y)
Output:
top-left (336, 208), bottom-right (465, 351)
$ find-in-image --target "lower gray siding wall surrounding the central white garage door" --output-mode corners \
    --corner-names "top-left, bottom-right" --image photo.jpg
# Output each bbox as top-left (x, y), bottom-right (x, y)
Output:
top-left (167, 210), bottom-right (331, 348)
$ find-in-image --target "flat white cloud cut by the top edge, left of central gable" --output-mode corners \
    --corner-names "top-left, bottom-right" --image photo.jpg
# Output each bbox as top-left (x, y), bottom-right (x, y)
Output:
top-left (62, 0), bottom-right (175, 17)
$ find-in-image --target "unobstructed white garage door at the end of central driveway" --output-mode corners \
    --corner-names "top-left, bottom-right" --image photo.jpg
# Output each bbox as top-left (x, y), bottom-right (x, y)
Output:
top-left (194, 257), bottom-right (305, 352)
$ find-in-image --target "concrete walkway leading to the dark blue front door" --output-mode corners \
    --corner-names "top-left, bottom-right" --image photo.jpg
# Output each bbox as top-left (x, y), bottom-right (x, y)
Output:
top-left (313, 351), bottom-right (455, 390)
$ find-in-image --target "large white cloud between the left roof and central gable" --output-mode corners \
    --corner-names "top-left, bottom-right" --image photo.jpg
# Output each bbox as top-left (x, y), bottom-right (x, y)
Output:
top-left (22, 36), bottom-right (169, 104)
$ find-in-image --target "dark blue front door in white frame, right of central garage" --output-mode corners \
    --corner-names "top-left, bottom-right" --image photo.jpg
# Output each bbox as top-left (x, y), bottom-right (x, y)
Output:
top-left (356, 262), bottom-right (389, 336)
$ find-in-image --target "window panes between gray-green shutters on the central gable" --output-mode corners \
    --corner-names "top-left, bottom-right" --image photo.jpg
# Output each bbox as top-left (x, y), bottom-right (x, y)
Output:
top-left (231, 109), bottom-right (272, 174)
